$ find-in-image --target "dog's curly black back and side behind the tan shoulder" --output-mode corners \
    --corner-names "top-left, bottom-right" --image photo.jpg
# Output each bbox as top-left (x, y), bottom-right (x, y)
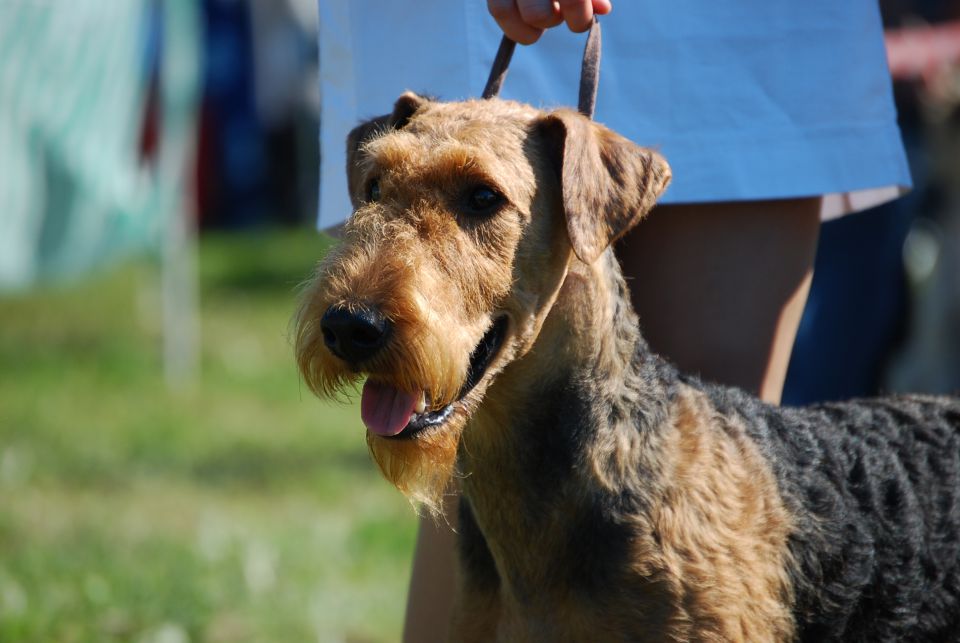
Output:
top-left (707, 387), bottom-right (960, 641)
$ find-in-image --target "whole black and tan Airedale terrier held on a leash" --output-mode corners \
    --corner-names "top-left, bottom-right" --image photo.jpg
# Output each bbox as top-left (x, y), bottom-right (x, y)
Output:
top-left (296, 93), bottom-right (960, 641)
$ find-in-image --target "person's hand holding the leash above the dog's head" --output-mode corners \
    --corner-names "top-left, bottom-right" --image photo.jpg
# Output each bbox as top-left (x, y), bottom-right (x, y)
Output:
top-left (487, 0), bottom-right (613, 45)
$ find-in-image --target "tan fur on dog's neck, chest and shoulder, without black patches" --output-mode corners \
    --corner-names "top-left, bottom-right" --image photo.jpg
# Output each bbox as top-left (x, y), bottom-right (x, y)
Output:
top-left (455, 252), bottom-right (794, 643)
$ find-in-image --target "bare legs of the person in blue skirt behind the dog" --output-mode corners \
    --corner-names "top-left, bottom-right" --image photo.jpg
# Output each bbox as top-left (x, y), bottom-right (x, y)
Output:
top-left (403, 198), bottom-right (820, 643)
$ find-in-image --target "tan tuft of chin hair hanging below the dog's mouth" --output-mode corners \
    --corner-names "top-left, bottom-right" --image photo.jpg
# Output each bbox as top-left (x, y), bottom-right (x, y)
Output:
top-left (367, 420), bottom-right (463, 519)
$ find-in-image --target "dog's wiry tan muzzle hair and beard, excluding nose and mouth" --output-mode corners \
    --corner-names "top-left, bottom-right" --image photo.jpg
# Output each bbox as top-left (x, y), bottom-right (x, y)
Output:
top-left (295, 239), bottom-right (498, 516)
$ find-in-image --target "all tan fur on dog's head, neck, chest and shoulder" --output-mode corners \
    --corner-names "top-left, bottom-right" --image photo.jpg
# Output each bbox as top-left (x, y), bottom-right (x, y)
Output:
top-left (296, 94), bottom-right (792, 641)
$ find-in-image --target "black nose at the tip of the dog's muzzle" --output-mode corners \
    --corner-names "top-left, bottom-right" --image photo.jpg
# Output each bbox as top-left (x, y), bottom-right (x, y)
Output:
top-left (320, 306), bottom-right (390, 364)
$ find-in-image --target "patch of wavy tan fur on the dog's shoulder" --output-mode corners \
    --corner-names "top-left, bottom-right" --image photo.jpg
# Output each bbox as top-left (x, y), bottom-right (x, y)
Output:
top-left (634, 391), bottom-right (793, 643)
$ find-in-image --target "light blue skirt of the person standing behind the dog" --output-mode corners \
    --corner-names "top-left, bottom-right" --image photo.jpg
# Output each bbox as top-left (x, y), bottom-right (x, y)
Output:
top-left (320, 0), bottom-right (910, 227)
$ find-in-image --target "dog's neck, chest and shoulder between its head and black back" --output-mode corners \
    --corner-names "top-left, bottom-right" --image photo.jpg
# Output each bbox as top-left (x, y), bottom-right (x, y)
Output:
top-left (460, 249), bottom-right (793, 641)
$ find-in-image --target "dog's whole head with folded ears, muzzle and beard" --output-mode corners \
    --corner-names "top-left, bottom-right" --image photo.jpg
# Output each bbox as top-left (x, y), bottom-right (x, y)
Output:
top-left (296, 93), bottom-right (670, 509)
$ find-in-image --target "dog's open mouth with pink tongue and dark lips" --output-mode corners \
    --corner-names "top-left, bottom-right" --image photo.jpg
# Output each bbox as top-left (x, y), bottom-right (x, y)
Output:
top-left (360, 316), bottom-right (508, 439)
